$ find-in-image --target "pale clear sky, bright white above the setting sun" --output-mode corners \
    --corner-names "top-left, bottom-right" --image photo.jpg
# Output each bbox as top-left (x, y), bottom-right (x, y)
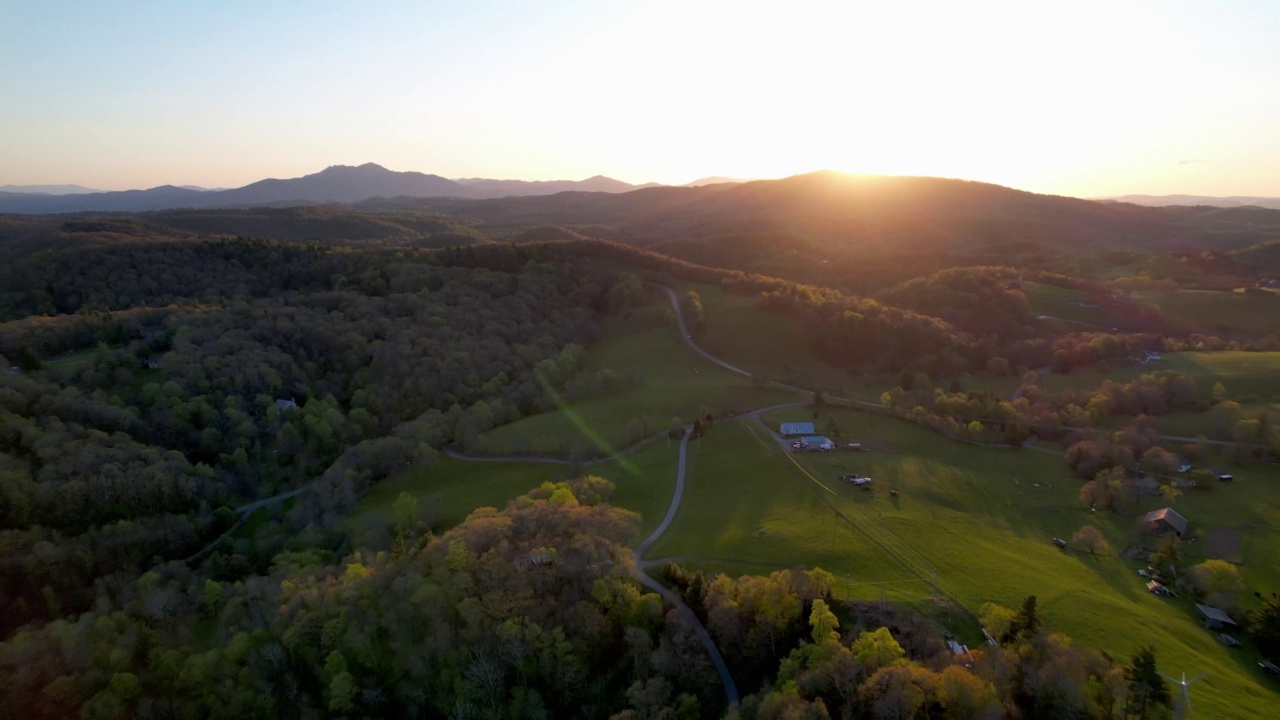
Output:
top-left (0, 0), bottom-right (1280, 197)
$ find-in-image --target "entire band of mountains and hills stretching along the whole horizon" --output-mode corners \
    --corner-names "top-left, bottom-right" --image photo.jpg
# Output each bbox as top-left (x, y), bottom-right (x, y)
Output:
top-left (10, 165), bottom-right (1280, 265)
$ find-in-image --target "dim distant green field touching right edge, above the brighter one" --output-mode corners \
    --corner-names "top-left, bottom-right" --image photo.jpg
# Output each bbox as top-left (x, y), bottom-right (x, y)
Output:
top-left (1134, 290), bottom-right (1280, 337)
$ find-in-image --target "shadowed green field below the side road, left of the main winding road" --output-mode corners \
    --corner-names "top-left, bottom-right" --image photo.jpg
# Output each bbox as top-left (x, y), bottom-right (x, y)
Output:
top-left (347, 442), bottom-right (676, 542)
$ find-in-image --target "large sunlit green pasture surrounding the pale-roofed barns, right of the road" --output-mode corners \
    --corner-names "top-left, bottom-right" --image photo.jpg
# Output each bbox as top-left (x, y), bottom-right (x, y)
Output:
top-left (649, 409), bottom-right (1280, 717)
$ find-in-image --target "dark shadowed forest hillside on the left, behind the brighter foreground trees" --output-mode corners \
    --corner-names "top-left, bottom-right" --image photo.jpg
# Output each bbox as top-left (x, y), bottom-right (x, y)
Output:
top-left (0, 230), bottom-right (650, 632)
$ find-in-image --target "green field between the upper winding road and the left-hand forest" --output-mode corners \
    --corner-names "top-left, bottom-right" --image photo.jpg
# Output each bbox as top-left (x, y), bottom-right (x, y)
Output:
top-left (480, 296), bottom-right (804, 456)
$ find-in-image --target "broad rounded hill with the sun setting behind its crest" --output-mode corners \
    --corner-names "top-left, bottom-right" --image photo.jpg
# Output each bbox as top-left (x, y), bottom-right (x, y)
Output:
top-left (368, 172), bottom-right (1280, 256)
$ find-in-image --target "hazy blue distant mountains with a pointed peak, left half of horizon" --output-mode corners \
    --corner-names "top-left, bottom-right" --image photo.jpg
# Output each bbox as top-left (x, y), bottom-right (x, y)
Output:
top-left (0, 163), bottom-right (680, 214)
